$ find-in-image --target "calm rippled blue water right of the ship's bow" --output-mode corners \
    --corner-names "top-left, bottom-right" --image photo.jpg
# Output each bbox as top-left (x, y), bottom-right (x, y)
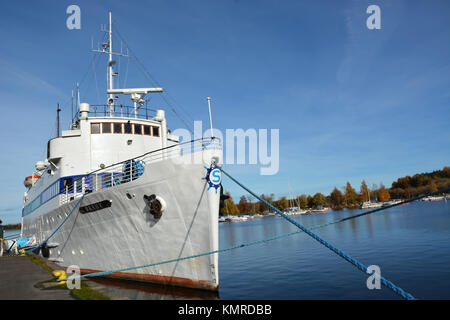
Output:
top-left (219, 201), bottom-right (450, 299)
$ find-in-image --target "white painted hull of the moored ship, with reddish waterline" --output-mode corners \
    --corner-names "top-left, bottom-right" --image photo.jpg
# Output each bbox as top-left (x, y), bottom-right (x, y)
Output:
top-left (23, 152), bottom-right (220, 290)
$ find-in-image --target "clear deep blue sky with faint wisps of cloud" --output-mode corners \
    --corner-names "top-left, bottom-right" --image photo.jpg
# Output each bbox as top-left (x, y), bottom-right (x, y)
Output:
top-left (0, 0), bottom-right (450, 223)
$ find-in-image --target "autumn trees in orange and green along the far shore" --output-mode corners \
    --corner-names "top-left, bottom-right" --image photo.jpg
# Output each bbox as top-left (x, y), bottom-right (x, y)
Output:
top-left (221, 167), bottom-right (450, 215)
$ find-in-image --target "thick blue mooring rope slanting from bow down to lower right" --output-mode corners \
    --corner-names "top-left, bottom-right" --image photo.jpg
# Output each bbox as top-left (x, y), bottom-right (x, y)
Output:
top-left (221, 168), bottom-right (415, 300)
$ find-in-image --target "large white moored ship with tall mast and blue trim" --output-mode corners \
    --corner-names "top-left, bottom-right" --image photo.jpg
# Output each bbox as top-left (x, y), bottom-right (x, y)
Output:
top-left (21, 12), bottom-right (222, 290)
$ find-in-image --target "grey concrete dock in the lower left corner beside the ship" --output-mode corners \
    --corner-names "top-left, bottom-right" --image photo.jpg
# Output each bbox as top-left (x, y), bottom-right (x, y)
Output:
top-left (0, 256), bottom-right (75, 300)
